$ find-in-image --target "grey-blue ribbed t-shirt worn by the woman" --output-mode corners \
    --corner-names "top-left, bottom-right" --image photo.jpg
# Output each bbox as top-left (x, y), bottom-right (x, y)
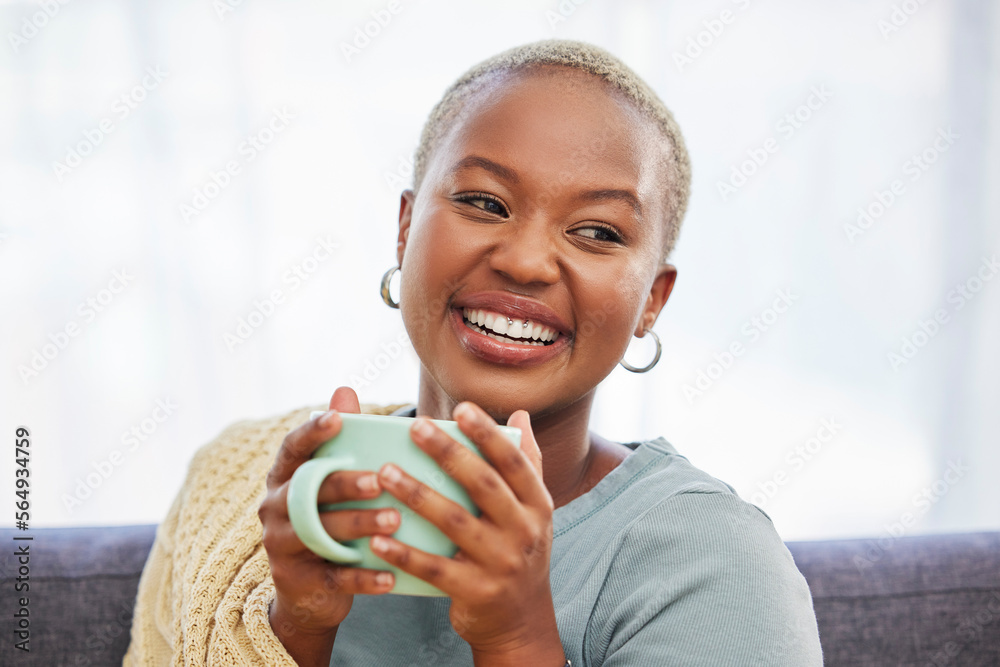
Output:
top-left (330, 408), bottom-right (823, 667)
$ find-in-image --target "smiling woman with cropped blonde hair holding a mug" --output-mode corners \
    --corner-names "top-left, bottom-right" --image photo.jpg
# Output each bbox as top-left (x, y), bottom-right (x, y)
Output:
top-left (126, 40), bottom-right (822, 667)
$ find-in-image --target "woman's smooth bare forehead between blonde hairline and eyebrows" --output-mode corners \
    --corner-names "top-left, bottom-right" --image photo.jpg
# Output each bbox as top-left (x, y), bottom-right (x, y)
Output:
top-left (431, 67), bottom-right (662, 210)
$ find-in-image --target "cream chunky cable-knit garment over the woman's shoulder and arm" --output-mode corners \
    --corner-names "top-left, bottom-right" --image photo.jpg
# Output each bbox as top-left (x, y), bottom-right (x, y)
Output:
top-left (123, 404), bottom-right (404, 666)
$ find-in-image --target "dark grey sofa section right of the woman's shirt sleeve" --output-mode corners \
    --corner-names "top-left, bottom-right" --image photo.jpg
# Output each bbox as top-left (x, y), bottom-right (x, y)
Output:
top-left (786, 532), bottom-right (1000, 667)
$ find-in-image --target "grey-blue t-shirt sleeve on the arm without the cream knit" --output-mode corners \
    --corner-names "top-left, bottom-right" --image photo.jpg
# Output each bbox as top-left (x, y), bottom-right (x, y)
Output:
top-left (589, 493), bottom-right (823, 667)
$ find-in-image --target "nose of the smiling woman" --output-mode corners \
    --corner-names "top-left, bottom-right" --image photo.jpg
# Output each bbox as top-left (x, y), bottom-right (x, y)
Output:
top-left (489, 220), bottom-right (559, 285)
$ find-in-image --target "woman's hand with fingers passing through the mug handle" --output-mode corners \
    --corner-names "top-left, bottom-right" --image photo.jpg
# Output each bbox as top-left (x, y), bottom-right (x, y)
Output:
top-left (258, 387), bottom-right (399, 666)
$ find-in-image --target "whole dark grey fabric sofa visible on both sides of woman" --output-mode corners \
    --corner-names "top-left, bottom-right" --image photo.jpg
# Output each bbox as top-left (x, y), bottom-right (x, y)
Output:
top-left (0, 526), bottom-right (1000, 667)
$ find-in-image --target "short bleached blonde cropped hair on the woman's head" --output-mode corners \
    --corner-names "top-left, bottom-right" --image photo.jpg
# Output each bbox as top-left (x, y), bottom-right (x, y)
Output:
top-left (413, 39), bottom-right (691, 261)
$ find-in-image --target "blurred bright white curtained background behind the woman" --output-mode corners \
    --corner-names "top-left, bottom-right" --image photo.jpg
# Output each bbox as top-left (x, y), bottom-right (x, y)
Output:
top-left (0, 0), bottom-right (1000, 540)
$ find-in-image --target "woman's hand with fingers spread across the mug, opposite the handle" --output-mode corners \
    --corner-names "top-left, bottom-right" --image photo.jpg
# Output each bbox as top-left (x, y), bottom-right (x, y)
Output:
top-left (371, 402), bottom-right (565, 666)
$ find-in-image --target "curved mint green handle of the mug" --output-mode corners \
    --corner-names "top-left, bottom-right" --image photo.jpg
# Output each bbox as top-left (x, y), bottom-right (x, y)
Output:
top-left (288, 457), bottom-right (362, 565)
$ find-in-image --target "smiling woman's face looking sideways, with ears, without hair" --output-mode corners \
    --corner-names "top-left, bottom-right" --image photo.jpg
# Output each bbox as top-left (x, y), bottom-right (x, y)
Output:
top-left (398, 68), bottom-right (676, 417)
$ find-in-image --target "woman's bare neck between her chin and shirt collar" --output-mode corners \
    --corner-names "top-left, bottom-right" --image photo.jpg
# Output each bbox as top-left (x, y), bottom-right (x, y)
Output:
top-left (417, 370), bottom-right (595, 508)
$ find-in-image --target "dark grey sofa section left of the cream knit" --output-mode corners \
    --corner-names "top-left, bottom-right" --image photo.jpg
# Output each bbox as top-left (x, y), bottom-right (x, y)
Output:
top-left (0, 526), bottom-right (156, 667)
